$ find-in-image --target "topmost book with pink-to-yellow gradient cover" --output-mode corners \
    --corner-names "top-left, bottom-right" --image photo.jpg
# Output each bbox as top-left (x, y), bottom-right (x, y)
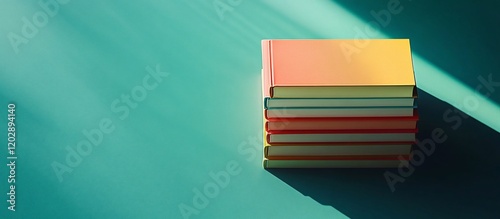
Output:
top-left (262, 39), bottom-right (415, 98)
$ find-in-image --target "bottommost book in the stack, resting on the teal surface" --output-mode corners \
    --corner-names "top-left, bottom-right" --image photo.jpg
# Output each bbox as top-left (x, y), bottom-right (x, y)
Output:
top-left (263, 156), bottom-right (409, 168)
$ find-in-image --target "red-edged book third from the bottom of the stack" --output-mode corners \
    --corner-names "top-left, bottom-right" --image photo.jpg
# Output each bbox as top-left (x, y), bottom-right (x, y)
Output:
top-left (266, 129), bottom-right (417, 144)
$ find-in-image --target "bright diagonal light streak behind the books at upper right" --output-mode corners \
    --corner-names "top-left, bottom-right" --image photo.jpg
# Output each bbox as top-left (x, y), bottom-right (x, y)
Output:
top-left (266, 0), bottom-right (500, 132)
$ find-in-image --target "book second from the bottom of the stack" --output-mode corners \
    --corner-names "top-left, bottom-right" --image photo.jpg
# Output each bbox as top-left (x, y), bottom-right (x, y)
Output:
top-left (264, 142), bottom-right (412, 159)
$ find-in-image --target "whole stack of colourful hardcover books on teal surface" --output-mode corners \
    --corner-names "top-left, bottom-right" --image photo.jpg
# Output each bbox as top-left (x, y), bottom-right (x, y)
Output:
top-left (262, 39), bottom-right (418, 168)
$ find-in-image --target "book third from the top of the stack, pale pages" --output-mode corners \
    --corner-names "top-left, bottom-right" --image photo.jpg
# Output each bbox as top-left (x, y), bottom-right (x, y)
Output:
top-left (264, 107), bottom-right (415, 119)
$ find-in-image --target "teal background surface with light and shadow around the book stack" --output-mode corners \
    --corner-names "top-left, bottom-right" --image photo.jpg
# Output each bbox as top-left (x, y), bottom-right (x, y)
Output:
top-left (0, 0), bottom-right (500, 218)
